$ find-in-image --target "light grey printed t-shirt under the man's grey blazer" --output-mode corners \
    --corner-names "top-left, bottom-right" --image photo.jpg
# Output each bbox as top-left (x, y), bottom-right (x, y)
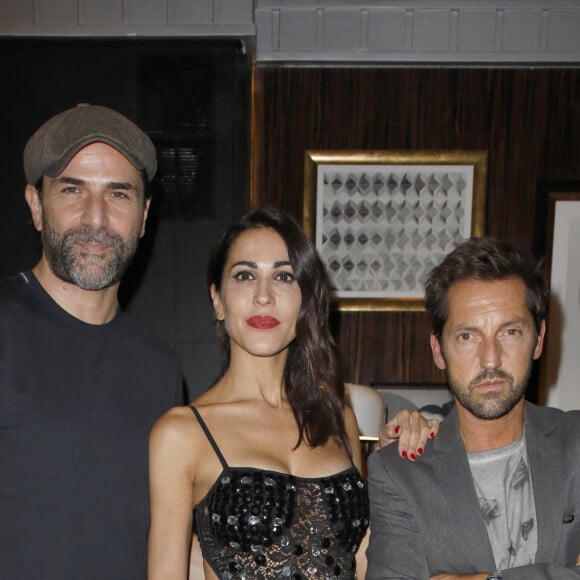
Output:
top-left (468, 431), bottom-right (538, 570)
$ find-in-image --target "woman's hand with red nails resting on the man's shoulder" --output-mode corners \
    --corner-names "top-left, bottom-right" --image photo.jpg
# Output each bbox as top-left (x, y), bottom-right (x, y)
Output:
top-left (379, 410), bottom-right (439, 461)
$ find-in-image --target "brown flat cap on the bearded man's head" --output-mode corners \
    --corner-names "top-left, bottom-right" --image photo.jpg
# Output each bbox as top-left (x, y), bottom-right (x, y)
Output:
top-left (24, 103), bottom-right (157, 185)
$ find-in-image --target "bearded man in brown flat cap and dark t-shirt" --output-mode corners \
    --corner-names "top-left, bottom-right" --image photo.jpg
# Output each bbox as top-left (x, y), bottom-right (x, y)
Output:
top-left (0, 105), bottom-right (183, 580)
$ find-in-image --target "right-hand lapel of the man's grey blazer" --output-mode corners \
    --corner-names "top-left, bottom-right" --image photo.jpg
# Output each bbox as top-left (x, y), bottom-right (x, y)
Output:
top-left (525, 403), bottom-right (564, 562)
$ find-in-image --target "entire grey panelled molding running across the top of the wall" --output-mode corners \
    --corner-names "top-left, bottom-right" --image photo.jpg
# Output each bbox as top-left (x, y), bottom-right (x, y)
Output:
top-left (0, 0), bottom-right (580, 64)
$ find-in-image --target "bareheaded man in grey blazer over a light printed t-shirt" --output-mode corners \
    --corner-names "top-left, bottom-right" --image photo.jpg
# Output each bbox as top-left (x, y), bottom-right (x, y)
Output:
top-left (366, 238), bottom-right (580, 580)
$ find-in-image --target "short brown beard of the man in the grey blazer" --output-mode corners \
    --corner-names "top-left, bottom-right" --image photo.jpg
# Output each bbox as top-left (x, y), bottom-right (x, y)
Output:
top-left (448, 359), bottom-right (532, 419)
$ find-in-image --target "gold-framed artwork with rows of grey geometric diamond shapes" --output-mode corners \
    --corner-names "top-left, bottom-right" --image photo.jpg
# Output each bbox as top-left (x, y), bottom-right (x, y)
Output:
top-left (303, 151), bottom-right (487, 310)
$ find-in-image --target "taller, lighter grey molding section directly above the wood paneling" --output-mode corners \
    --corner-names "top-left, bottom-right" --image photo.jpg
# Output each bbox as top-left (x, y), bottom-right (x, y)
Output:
top-left (255, 0), bottom-right (580, 63)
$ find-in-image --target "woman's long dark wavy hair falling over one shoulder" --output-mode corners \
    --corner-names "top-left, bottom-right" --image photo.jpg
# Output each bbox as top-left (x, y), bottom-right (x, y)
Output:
top-left (207, 208), bottom-right (347, 447)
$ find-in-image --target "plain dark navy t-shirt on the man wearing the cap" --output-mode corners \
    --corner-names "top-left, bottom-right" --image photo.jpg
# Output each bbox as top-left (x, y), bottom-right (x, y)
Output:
top-left (0, 272), bottom-right (183, 580)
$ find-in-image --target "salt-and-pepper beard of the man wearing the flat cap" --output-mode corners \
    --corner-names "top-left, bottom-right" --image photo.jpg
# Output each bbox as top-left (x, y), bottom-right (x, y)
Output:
top-left (42, 220), bottom-right (139, 290)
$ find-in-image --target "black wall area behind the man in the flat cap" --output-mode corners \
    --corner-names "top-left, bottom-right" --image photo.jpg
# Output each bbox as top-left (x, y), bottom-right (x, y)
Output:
top-left (0, 38), bottom-right (251, 396)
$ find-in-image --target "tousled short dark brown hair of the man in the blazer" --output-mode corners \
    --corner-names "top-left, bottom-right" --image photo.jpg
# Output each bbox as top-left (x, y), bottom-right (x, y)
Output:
top-left (425, 238), bottom-right (549, 338)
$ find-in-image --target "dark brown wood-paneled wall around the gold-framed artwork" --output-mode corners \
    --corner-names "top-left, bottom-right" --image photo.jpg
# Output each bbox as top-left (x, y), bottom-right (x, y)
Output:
top-left (251, 65), bottom-right (580, 383)
